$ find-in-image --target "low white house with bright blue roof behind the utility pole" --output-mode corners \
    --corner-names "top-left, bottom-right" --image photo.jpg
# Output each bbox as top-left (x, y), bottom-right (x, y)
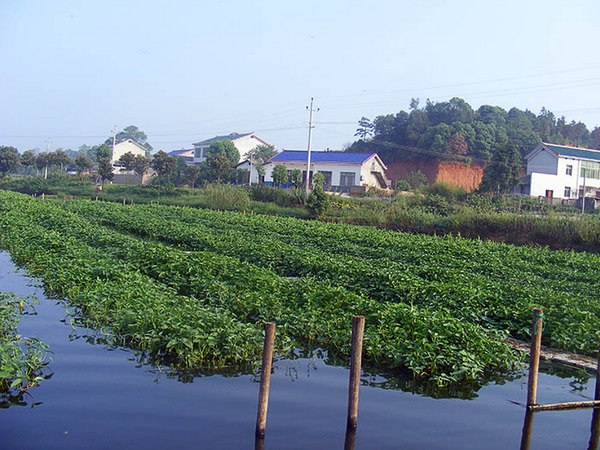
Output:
top-left (264, 150), bottom-right (390, 192)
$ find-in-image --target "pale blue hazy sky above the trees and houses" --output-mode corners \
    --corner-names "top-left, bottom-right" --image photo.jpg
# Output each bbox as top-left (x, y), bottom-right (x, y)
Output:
top-left (0, 0), bottom-right (600, 152)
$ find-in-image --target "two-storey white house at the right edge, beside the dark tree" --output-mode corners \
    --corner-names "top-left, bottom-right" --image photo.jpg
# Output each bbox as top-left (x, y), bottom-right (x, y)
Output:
top-left (518, 143), bottom-right (600, 199)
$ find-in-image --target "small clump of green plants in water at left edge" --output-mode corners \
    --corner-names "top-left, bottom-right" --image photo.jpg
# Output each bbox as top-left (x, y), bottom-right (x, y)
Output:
top-left (0, 292), bottom-right (51, 408)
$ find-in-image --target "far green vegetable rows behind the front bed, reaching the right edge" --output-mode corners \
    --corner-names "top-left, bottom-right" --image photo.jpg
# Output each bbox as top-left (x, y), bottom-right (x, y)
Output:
top-left (58, 202), bottom-right (600, 354)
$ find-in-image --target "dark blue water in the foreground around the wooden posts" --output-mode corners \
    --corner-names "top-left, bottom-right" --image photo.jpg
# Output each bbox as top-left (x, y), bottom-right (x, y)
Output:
top-left (0, 253), bottom-right (595, 449)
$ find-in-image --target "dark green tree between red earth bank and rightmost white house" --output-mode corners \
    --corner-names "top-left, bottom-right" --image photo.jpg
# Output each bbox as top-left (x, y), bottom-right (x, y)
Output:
top-left (481, 142), bottom-right (521, 194)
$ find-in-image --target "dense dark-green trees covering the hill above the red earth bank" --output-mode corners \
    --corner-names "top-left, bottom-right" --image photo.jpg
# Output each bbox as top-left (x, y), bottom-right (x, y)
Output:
top-left (347, 97), bottom-right (600, 191)
